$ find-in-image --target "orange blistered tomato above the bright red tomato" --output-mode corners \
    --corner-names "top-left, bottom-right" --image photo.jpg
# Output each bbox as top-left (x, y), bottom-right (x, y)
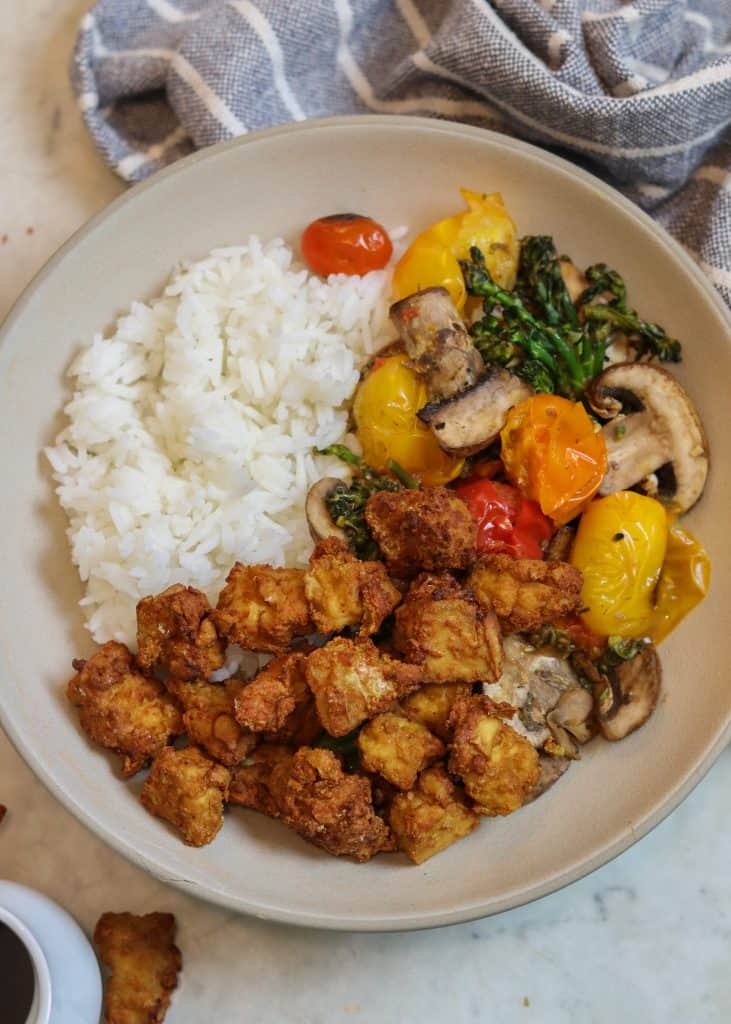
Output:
top-left (500, 394), bottom-right (607, 523)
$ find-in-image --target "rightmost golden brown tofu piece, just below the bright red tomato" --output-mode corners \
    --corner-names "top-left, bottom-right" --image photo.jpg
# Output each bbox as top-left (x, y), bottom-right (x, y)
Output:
top-left (468, 555), bottom-right (583, 633)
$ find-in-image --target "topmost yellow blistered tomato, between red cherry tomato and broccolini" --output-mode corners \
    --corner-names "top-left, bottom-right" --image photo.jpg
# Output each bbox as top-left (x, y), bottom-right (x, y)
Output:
top-left (393, 188), bottom-right (519, 311)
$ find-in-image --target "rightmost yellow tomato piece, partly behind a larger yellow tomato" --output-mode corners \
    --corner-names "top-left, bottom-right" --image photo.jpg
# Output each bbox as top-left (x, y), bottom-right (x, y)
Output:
top-left (649, 526), bottom-right (711, 643)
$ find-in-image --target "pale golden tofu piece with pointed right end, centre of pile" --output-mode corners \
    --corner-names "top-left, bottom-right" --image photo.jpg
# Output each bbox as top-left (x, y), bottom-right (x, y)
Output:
top-left (305, 637), bottom-right (422, 736)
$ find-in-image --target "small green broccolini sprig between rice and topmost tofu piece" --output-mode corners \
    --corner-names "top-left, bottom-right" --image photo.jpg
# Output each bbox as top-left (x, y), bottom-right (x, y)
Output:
top-left (315, 444), bottom-right (401, 561)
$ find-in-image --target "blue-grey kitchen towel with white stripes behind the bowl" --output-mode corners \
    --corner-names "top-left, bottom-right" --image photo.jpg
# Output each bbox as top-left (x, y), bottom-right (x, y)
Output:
top-left (73, 0), bottom-right (731, 304)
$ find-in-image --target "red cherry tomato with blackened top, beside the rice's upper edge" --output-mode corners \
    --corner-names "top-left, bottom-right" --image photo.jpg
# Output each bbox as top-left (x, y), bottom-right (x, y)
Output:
top-left (302, 213), bottom-right (393, 278)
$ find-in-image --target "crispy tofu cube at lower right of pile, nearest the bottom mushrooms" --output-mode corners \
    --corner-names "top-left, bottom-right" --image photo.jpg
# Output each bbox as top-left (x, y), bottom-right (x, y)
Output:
top-left (449, 696), bottom-right (541, 817)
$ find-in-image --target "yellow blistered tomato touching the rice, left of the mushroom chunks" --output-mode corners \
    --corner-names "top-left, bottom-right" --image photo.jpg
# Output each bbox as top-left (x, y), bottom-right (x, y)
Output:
top-left (353, 355), bottom-right (464, 485)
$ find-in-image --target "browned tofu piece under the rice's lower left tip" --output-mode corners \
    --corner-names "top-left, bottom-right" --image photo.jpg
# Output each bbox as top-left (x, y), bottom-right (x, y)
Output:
top-left (137, 584), bottom-right (224, 679)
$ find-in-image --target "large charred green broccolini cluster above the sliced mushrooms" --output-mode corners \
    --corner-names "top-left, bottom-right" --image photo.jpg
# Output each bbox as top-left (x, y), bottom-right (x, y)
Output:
top-left (461, 236), bottom-right (681, 399)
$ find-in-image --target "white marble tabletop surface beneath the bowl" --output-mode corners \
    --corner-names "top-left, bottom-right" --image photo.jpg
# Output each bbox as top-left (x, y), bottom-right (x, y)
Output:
top-left (0, 0), bottom-right (731, 1024)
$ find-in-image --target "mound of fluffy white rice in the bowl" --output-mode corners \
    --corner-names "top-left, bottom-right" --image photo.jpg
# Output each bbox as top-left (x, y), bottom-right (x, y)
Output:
top-left (46, 237), bottom-right (401, 645)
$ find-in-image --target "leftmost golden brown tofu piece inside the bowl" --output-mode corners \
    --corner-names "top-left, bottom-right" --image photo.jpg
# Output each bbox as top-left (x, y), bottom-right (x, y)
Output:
top-left (67, 640), bottom-right (183, 778)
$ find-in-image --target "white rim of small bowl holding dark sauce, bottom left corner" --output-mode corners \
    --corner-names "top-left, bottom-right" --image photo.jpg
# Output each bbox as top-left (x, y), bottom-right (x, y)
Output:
top-left (0, 882), bottom-right (101, 1024)
